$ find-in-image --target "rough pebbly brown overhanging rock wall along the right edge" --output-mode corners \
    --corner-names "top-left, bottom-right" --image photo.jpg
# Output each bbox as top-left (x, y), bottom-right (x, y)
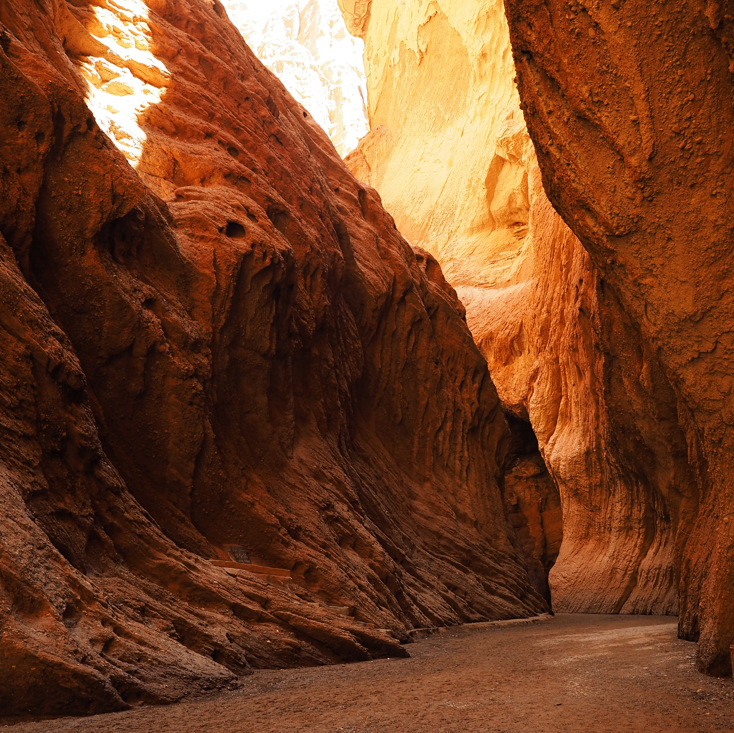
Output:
top-left (505, 0), bottom-right (734, 674)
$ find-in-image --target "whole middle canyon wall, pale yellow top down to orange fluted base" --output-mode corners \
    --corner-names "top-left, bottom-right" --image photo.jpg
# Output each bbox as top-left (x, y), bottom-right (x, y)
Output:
top-left (342, 0), bottom-right (699, 636)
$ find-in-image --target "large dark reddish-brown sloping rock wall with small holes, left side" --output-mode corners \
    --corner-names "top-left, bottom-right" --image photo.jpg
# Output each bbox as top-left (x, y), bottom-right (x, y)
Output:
top-left (0, 0), bottom-right (545, 714)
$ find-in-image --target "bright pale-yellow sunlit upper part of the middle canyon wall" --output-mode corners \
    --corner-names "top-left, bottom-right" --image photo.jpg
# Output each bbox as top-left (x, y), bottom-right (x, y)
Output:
top-left (343, 0), bottom-right (529, 287)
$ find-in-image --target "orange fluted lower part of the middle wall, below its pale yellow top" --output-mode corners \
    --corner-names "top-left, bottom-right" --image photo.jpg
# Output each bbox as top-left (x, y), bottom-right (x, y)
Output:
top-left (459, 166), bottom-right (697, 614)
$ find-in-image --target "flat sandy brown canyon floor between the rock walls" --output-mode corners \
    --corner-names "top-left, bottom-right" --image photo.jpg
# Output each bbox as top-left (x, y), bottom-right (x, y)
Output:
top-left (5, 615), bottom-right (734, 733)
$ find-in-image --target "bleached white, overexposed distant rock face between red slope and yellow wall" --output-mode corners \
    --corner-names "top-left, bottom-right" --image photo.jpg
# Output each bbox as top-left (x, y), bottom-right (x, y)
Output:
top-left (218, 0), bottom-right (369, 156)
